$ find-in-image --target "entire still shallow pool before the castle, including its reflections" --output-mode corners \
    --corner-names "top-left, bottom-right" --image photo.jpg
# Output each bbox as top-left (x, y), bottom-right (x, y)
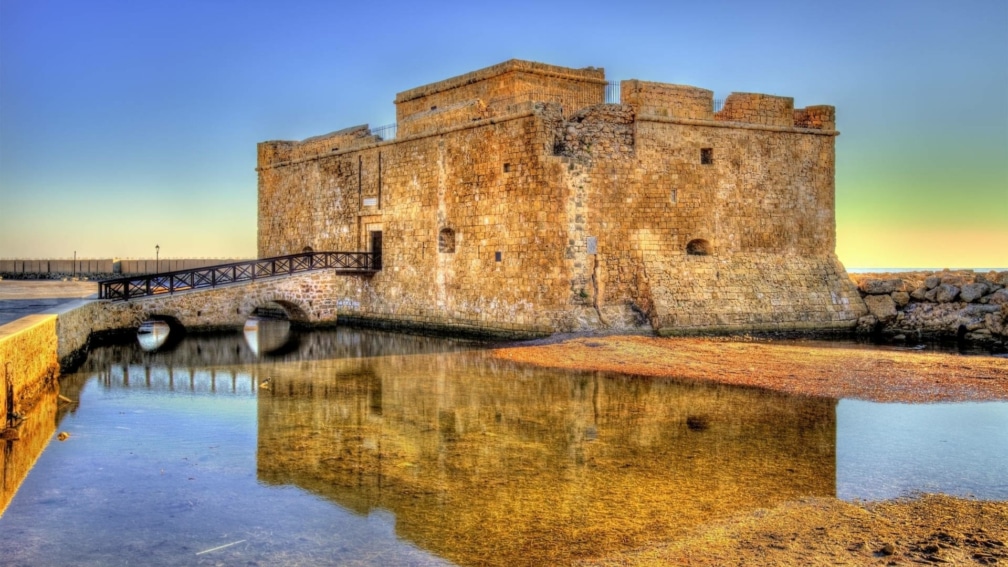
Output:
top-left (0, 329), bottom-right (1008, 565)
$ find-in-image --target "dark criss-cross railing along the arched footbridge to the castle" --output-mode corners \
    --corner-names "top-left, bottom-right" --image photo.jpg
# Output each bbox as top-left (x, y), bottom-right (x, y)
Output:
top-left (98, 248), bottom-right (381, 301)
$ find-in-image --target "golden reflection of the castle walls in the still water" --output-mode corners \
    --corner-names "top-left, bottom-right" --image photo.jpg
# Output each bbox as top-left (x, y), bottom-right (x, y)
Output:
top-left (257, 354), bottom-right (836, 565)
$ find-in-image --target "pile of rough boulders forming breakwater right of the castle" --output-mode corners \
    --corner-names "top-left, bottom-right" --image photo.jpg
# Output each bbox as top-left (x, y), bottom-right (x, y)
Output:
top-left (851, 269), bottom-right (1008, 348)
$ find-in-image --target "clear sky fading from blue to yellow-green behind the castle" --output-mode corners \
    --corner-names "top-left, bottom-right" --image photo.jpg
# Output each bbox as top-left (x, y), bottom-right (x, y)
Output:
top-left (0, 0), bottom-right (1008, 268)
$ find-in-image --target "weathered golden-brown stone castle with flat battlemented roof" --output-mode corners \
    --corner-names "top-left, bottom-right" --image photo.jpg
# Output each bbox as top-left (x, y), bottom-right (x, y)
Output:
top-left (257, 60), bottom-right (866, 336)
